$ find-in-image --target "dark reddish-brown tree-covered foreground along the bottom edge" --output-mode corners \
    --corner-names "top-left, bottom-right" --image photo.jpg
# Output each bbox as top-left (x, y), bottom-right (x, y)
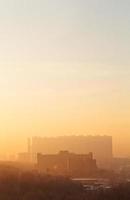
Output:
top-left (0, 165), bottom-right (130, 200)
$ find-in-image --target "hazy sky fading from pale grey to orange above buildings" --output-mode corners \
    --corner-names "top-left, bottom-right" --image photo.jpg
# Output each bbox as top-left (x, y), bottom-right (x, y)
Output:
top-left (0, 0), bottom-right (130, 155)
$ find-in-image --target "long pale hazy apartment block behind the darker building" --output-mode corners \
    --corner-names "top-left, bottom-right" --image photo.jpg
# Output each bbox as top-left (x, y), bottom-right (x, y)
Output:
top-left (30, 136), bottom-right (113, 168)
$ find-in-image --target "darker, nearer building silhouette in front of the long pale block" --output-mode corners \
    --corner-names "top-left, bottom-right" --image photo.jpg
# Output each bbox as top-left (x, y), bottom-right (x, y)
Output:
top-left (37, 151), bottom-right (97, 177)
